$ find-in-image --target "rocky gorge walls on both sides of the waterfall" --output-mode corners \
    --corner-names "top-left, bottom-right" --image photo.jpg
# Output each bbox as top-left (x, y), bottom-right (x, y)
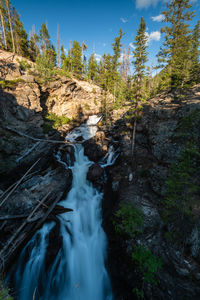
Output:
top-left (0, 52), bottom-right (200, 300)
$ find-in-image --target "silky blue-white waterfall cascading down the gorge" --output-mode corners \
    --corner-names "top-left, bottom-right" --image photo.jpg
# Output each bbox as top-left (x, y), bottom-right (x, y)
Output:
top-left (11, 118), bottom-right (116, 300)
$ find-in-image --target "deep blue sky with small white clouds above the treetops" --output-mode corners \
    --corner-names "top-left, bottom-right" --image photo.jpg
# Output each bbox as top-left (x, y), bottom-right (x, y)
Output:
top-left (12, 0), bottom-right (200, 72)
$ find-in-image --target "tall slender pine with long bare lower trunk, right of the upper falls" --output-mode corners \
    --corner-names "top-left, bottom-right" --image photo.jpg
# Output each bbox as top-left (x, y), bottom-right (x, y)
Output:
top-left (131, 18), bottom-right (148, 156)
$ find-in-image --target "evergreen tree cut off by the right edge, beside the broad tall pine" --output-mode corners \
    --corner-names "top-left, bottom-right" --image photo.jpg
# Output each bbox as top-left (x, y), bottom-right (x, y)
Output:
top-left (190, 21), bottom-right (200, 83)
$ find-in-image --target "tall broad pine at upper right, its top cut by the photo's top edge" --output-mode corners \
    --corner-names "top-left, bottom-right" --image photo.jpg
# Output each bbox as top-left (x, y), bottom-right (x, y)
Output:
top-left (159, 0), bottom-right (193, 88)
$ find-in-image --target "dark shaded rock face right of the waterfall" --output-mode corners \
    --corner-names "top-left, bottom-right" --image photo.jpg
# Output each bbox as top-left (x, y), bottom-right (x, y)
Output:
top-left (104, 86), bottom-right (200, 300)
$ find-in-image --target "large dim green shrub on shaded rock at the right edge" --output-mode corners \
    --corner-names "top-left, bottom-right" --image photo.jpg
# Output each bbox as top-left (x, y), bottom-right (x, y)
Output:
top-left (162, 145), bottom-right (200, 243)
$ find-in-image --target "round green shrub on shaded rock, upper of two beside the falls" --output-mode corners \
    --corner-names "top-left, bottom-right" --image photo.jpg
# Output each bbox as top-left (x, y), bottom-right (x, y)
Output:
top-left (113, 204), bottom-right (144, 238)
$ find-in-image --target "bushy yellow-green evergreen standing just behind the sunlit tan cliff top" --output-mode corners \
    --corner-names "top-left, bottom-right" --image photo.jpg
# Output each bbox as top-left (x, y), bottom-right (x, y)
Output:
top-left (71, 41), bottom-right (83, 75)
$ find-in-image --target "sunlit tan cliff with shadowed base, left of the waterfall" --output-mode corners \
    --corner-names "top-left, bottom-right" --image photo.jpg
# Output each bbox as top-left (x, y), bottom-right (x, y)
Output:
top-left (0, 57), bottom-right (112, 182)
